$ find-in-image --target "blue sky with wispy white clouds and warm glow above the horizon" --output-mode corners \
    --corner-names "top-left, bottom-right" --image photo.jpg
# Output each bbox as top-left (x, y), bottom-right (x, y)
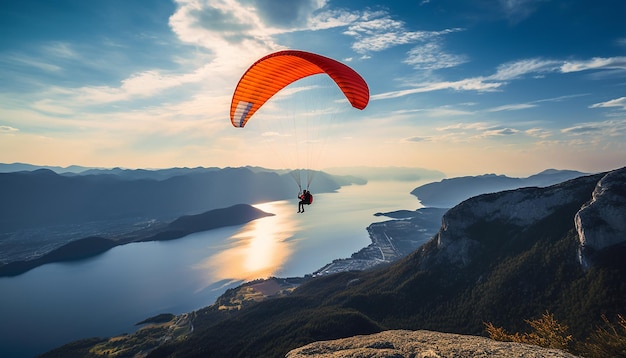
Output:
top-left (0, 0), bottom-right (626, 176)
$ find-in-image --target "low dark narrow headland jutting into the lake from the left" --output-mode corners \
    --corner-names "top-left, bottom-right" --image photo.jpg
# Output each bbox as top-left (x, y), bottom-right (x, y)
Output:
top-left (0, 204), bottom-right (274, 277)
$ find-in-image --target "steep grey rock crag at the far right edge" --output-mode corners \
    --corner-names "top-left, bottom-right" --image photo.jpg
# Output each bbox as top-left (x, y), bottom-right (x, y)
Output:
top-left (574, 167), bottom-right (626, 267)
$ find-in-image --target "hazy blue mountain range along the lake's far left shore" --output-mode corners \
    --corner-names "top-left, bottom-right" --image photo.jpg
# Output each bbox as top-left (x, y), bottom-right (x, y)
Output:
top-left (0, 168), bottom-right (352, 232)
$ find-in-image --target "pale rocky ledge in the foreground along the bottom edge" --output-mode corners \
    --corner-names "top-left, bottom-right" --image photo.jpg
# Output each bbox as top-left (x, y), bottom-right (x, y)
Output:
top-left (286, 330), bottom-right (575, 358)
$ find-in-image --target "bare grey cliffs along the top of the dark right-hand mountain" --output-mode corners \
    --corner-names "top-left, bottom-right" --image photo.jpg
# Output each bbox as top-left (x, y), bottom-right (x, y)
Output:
top-left (428, 168), bottom-right (626, 267)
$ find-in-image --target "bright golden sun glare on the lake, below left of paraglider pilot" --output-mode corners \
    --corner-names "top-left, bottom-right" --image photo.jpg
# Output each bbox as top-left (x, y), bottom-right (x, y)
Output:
top-left (197, 201), bottom-right (297, 282)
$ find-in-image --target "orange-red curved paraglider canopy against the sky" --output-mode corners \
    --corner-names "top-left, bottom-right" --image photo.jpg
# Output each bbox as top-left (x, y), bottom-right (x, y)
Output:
top-left (230, 50), bottom-right (369, 128)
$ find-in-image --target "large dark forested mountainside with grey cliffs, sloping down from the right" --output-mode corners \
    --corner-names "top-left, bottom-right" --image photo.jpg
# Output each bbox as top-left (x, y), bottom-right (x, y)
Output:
top-left (44, 168), bottom-right (626, 357)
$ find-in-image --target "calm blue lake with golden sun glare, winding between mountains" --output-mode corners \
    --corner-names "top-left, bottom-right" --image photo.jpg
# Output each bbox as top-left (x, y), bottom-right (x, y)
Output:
top-left (0, 181), bottom-right (425, 357)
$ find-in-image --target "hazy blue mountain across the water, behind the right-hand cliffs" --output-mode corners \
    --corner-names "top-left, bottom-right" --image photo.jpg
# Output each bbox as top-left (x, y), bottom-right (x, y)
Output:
top-left (411, 169), bottom-right (586, 208)
